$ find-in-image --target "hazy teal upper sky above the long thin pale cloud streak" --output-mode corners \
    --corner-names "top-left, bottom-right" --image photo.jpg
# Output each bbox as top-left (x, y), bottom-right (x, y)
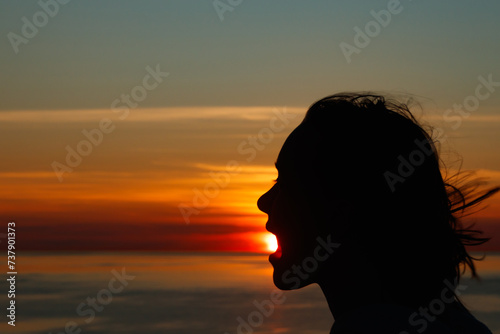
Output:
top-left (0, 0), bottom-right (500, 112)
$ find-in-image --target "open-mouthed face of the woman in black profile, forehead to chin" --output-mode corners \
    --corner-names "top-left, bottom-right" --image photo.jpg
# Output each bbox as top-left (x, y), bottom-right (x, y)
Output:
top-left (257, 125), bottom-right (330, 290)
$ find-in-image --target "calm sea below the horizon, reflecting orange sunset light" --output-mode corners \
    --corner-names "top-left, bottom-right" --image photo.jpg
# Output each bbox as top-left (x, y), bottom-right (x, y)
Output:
top-left (0, 253), bottom-right (500, 334)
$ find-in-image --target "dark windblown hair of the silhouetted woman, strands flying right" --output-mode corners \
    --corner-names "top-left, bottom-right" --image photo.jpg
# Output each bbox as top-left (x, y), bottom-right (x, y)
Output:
top-left (301, 93), bottom-right (500, 306)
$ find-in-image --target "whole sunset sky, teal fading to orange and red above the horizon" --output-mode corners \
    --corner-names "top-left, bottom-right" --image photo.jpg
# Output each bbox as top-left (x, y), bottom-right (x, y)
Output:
top-left (0, 0), bottom-right (500, 252)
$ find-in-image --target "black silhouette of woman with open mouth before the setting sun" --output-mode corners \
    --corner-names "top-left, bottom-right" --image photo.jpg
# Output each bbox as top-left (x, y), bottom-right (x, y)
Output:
top-left (258, 93), bottom-right (498, 334)
